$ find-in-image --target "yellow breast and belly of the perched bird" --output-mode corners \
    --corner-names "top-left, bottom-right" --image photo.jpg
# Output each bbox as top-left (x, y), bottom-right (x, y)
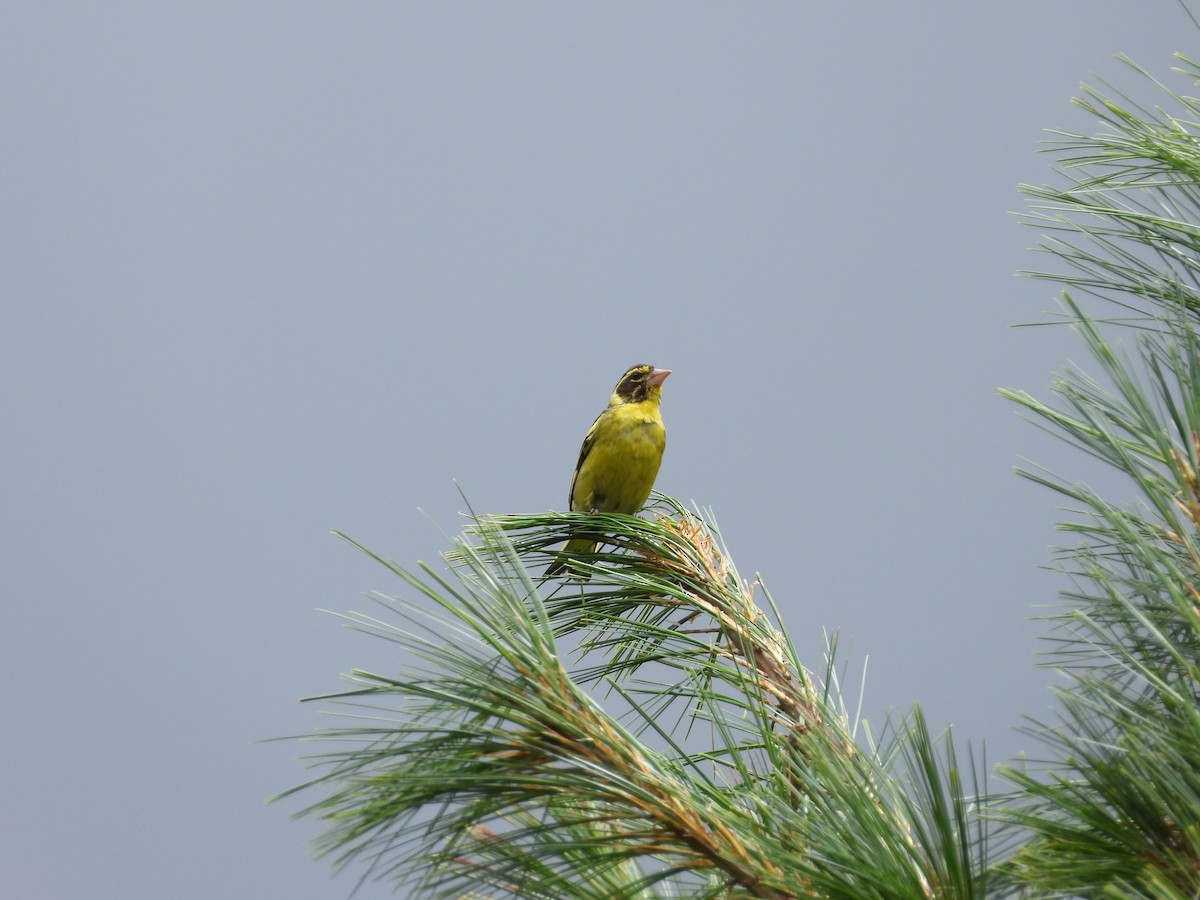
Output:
top-left (571, 397), bottom-right (667, 515)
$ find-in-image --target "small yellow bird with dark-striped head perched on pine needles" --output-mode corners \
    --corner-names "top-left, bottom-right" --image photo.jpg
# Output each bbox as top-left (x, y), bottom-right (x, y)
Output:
top-left (546, 364), bottom-right (671, 576)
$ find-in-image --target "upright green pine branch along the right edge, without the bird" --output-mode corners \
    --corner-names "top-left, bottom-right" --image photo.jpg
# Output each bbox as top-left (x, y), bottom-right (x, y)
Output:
top-left (994, 51), bottom-right (1200, 898)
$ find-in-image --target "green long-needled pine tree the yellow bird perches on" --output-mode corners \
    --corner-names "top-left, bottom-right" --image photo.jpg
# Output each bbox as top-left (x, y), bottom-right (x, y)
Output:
top-left (276, 49), bottom-right (1200, 900)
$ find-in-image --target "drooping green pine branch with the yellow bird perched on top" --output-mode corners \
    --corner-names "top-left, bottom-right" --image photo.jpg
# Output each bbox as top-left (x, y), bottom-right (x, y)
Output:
top-left (276, 497), bottom-right (985, 899)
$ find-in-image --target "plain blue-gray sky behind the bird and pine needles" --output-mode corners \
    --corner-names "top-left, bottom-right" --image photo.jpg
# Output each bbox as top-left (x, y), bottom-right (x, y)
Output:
top-left (7, 0), bottom-right (1196, 899)
